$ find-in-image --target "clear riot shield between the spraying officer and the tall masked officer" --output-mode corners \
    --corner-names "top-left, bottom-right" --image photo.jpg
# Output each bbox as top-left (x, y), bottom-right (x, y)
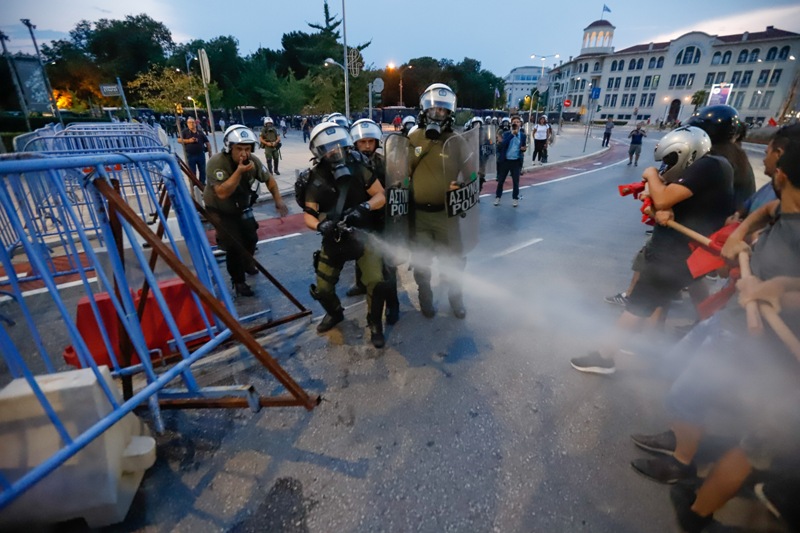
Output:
top-left (383, 133), bottom-right (411, 265)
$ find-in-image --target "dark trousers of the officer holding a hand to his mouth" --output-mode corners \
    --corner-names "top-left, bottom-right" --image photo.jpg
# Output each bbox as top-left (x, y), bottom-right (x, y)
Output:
top-left (209, 210), bottom-right (258, 283)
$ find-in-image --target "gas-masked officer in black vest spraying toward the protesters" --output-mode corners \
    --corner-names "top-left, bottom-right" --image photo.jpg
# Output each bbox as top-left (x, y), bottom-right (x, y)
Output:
top-left (303, 122), bottom-right (386, 348)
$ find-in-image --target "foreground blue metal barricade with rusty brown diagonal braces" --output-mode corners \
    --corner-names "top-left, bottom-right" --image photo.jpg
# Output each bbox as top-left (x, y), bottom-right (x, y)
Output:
top-left (0, 151), bottom-right (318, 511)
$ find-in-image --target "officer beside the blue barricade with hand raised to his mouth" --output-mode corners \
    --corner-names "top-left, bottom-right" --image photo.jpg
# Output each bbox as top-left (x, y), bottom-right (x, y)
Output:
top-left (203, 125), bottom-right (289, 296)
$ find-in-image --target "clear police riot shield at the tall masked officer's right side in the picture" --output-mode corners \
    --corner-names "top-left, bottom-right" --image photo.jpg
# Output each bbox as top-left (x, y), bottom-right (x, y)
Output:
top-left (442, 128), bottom-right (481, 255)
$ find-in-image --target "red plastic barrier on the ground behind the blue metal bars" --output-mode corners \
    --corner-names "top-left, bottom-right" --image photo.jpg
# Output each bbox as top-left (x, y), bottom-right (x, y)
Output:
top-left (63, 278), bottom-right (211, 368)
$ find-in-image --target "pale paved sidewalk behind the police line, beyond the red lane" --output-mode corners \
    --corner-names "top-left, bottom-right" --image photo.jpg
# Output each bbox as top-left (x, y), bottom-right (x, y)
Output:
top-left (170, 124), bottom-right (613, 201)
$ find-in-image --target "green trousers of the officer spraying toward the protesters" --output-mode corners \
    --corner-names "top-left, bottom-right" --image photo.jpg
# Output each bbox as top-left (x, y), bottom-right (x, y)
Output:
top-left (311, 242), bottom-right (383, 314)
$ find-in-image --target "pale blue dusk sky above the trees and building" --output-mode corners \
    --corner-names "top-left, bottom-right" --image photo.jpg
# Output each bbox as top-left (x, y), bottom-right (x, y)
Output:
top-left (0, 0), bottom-right (800, 77)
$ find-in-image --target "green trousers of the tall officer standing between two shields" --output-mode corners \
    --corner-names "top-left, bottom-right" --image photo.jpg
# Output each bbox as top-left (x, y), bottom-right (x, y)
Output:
top-left (412, 206), bottom-right (467, 297)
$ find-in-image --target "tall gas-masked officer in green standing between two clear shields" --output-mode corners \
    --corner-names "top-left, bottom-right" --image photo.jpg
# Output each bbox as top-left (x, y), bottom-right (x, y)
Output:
top-left (408, 83), bottom-right (477, 318)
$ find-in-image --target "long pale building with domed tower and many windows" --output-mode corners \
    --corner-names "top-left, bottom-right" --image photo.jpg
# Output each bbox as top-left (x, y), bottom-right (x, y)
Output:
top-left (536, 20), bottom-right (800, 124)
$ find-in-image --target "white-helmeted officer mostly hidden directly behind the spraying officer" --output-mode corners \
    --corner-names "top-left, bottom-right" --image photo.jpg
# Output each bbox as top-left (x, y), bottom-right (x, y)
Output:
top-left (347, 118), bottom-right (400, 324)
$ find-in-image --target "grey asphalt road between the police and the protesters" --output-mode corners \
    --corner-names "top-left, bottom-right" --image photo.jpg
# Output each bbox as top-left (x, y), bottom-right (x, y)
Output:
top-left (87, 139), bottom-right (780, 533)
